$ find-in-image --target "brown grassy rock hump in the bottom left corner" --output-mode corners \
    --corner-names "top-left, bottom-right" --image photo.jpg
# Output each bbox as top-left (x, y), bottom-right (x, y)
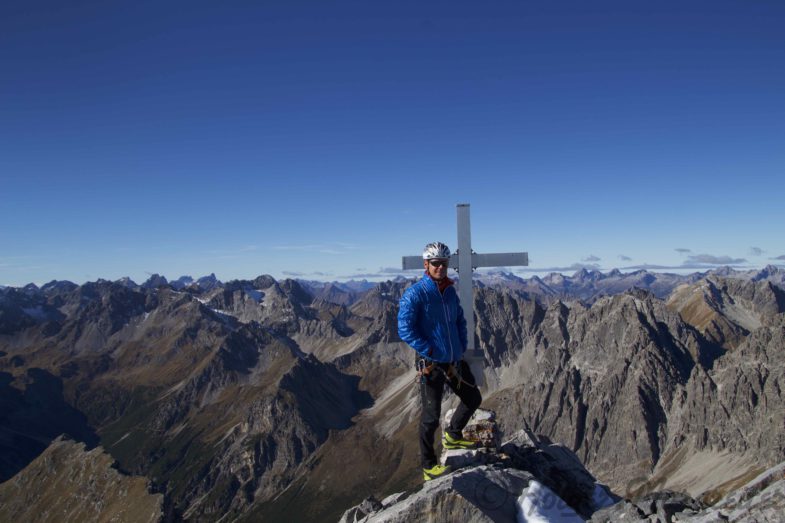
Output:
top-left (0, 438), bottom-right (164, 523)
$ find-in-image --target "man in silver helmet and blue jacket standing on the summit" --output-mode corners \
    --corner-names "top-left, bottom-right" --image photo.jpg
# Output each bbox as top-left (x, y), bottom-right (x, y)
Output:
top-left (398, 242), bottom-right (482, 481)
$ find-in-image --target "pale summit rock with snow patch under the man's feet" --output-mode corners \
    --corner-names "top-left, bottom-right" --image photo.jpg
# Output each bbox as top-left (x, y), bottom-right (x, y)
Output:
top-left (340, 410), bottom-right (618, 523)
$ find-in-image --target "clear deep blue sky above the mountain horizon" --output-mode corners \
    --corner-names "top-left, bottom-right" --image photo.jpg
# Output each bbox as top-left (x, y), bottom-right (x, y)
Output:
top-left (0, 0), bottom-right (785, 285)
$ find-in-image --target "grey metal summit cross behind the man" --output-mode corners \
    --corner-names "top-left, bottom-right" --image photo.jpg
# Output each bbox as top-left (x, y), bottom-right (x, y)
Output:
top-left (402, 203), bottom-right (529, 386)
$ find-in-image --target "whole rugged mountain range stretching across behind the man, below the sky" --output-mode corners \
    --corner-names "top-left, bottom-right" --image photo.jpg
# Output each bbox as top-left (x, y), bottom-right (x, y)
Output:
top-left (0, 268), bottom-right (785, 521)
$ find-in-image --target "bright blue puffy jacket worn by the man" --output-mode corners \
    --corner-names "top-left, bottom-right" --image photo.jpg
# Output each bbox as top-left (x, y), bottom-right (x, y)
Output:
top-left (398, 274), bottom-right (467, 363)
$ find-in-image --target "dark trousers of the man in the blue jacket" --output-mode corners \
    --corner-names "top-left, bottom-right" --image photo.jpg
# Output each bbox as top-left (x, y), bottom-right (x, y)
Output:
top-left (420, 361), bottom-right (482, 468)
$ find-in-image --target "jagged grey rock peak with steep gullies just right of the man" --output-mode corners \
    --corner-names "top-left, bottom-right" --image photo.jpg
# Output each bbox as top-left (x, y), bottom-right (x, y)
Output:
top-left (479, 292), bottom-right (702, 494)
